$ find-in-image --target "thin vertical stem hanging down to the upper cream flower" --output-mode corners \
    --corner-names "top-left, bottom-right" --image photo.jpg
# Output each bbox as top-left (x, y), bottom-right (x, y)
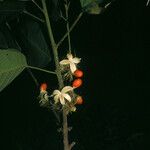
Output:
top-left (65, 0), bottom-right (71, 53)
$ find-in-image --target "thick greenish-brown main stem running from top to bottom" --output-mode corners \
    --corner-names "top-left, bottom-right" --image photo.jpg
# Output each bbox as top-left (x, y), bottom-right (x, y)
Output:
top-left (42, 0), bottom-right (70, 150)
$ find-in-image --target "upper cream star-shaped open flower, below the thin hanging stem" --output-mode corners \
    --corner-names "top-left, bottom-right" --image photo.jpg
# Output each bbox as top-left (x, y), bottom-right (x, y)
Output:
top-left (60, 54), bottom-right (81, 73)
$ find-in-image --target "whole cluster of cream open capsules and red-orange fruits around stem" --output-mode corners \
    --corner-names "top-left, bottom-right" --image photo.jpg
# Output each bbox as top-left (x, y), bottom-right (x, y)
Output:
top-left (39, 54), bottom-right (83, 112)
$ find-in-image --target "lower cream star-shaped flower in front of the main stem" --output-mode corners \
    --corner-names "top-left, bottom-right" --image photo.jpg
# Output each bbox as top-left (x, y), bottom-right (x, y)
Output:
top-left (52, 86), bottom-right (73, 105)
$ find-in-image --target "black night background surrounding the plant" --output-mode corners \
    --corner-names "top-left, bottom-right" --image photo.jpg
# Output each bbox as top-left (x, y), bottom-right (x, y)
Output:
top-left (0, 0), bottom-right (150, 150)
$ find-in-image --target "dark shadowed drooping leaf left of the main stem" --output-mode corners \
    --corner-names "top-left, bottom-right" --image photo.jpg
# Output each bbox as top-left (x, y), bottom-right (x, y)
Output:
top-left (12, 18), bottom-right (51, 67)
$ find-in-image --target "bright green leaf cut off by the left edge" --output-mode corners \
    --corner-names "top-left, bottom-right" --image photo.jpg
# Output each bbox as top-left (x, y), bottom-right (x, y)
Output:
top-left (0, 49), bottom-right (27, 92)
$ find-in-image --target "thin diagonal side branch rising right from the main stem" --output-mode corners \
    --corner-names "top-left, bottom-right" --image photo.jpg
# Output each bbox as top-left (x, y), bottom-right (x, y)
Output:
top-left (57, 12), bottom-right (83, 47)
